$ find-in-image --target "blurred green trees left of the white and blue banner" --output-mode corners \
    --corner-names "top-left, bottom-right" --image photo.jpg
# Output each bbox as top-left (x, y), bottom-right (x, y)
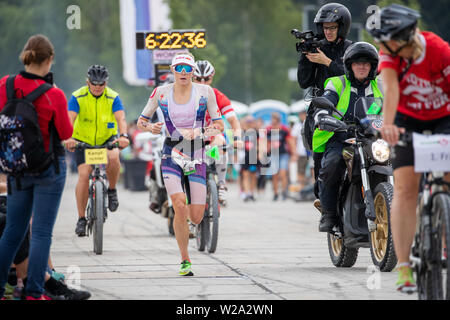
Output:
top-left (0, 0), bottom-right (149, 120)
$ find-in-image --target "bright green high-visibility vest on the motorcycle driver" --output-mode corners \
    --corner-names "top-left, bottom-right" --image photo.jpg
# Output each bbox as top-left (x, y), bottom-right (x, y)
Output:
top-left (313, 75), bottom-right (383, 153)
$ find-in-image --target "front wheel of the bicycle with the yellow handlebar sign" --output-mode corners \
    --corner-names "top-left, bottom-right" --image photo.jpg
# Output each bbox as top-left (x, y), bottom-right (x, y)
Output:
top-left (92, 181), bottom-right (106, 254)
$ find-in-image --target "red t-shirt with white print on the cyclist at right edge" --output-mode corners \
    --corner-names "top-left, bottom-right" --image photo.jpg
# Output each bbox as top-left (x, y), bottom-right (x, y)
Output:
top-left (378, 32), bottom-right (450, 121)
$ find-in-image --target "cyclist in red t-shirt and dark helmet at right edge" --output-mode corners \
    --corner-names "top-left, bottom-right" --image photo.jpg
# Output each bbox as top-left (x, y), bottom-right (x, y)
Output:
top-left (367, 5), bottom-right (450, 292)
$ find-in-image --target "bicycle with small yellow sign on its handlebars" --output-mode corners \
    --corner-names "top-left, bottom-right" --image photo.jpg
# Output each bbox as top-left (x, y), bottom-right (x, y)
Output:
top-left (75, 142), bottom-right (119, 255)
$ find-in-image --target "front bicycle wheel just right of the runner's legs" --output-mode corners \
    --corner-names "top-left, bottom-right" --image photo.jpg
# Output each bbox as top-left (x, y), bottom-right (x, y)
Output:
top-left (204, 178), bottom-right (219, 253)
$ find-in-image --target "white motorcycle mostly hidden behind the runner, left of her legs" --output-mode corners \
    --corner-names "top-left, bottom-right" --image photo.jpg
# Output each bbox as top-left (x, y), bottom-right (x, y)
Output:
top-left (136, 132), bottom-right (175, 235)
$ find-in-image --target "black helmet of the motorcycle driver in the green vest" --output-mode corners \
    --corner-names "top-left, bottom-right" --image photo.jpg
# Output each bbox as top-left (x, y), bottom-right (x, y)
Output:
top-left (343, 41), bottom-right (379, 82)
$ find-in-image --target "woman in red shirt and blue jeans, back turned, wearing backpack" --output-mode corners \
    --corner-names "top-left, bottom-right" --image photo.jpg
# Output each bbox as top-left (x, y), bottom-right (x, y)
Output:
top-left (0, 35), bottom-right (73, 300)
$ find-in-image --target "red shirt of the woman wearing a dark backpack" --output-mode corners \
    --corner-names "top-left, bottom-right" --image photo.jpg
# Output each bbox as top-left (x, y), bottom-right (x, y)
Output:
top-left (0, 72), bottom-right (73, 152)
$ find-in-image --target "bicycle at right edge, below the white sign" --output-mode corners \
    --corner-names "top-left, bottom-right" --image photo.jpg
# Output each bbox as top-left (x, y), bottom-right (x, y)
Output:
top-left (399, 133), bottom-right (450, 300)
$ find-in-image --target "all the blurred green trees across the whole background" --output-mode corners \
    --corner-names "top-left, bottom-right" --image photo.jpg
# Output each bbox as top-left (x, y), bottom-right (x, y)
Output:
top-left (0, 0), bottom-right (450, 120)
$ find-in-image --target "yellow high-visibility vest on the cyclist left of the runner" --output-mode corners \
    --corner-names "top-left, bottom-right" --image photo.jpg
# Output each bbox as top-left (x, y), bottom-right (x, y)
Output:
top-left (72, 86), bottom-right (119, 146)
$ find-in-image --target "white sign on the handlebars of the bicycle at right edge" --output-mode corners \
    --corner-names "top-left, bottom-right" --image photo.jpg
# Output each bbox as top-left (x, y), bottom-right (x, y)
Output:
top-left (413, 133), bottom-right (450, 172)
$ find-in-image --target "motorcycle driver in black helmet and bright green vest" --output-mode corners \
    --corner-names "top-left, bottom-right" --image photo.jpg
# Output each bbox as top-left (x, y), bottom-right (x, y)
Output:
top-left (312, 42), bottom-right (383, 232)
